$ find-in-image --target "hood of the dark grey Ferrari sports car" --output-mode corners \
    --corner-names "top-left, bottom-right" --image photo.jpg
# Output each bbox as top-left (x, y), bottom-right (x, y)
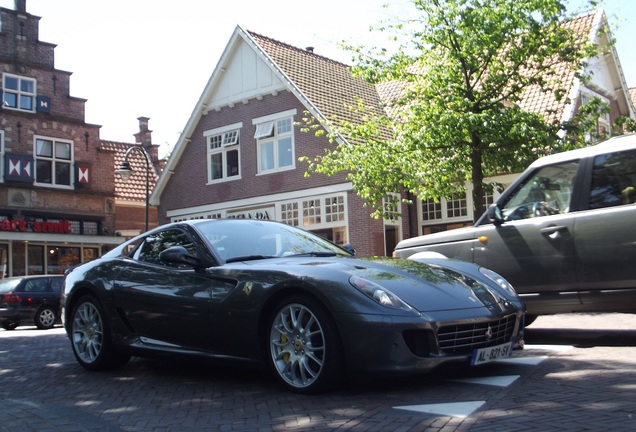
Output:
top-left (251, 258), bottom-right (521, 313)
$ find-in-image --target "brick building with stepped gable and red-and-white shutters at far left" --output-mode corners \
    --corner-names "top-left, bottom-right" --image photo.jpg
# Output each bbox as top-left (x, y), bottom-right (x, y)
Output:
top-left (0, 0), bottom-right (160, 278)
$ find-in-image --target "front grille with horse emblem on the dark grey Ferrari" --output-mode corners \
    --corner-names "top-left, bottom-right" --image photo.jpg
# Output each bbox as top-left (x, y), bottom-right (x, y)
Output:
top-left (437, 314), bottom-right (517, 355)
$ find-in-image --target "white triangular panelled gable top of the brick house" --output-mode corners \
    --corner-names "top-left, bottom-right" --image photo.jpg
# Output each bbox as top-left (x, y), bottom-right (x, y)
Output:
top-left (207, 39), bottom-right (285, 109)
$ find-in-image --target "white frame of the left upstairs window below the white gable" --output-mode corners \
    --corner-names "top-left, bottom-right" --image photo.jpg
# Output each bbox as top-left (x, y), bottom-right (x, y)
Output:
top-left (203, 122), bottom-right (243, 184)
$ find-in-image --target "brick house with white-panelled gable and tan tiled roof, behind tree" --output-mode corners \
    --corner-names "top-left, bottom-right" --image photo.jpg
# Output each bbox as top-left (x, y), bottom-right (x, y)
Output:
top-left (151, 12), bottom-right (635, 256)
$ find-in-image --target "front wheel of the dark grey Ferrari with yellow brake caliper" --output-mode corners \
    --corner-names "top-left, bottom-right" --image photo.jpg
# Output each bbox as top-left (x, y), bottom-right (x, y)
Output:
top-left (267, 296), bottom-right (345, 394)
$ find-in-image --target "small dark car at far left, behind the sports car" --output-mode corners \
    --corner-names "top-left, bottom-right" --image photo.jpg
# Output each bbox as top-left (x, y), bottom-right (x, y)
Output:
top-left (0, 275), bottom-right (64, 330)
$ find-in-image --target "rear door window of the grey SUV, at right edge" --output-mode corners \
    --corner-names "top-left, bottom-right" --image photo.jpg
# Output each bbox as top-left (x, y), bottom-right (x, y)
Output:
top-left (589, 150), bottom-right (636, 209)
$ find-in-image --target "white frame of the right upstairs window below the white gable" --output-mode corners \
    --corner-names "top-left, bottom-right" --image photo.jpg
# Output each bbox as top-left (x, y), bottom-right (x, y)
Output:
top-left (252, 109), bottom-right (297, 175)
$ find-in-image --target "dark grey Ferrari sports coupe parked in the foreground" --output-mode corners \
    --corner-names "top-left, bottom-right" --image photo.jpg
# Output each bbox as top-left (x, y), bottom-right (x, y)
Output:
top-left (64, 219), bottom-right (524, 393)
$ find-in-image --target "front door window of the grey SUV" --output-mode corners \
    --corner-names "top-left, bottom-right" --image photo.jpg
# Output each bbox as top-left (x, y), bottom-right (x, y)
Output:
top-left (501, 160), bottom-right (579, 220)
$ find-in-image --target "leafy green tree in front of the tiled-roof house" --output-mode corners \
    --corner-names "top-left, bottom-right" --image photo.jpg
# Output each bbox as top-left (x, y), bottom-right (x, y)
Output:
top-left (304, 0), bottom-right (598, 221)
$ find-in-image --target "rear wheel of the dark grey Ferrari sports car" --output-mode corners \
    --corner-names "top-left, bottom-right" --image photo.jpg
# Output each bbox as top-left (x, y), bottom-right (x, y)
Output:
top-left (69, 295), bottom-right (130, 371)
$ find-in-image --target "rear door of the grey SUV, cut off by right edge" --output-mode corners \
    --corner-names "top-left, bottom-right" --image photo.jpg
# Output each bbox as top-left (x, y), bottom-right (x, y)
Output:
top-left (575, 150), bottom-right (636, 311)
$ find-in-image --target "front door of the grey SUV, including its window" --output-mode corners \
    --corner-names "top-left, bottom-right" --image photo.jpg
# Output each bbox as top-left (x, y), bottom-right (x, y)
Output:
top-left (473, 160), bottom-right (580, 314)
